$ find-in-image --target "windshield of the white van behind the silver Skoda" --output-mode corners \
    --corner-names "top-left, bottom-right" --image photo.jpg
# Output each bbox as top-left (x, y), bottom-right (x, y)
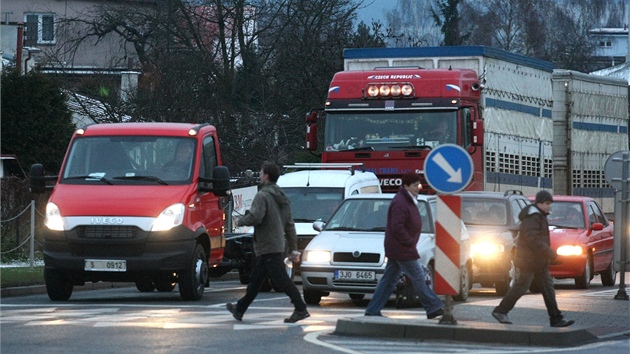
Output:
top-left (282, 187), bottom-right (344, 222)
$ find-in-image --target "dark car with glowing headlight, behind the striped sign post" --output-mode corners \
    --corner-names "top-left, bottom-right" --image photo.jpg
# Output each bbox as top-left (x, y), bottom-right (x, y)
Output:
top-left (457, 190), bottom-right (531, 295)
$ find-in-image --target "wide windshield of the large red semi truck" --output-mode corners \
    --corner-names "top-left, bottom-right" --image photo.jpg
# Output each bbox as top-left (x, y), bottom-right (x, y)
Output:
top-left (324, 111), bottom-right (457, 151)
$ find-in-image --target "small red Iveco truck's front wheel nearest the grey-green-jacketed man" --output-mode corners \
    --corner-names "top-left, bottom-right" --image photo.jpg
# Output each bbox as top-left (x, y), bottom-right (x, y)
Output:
top-left (179, 244), bottom-right (208, 301)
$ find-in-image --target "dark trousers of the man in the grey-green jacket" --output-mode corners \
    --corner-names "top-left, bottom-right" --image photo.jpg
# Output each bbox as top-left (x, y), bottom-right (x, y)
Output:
top-left (236, 253), bottom-right (306, 313)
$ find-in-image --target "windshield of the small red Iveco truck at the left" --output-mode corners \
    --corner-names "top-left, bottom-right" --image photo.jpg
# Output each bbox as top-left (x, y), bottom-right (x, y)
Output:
top-left (61, 136), bottom-right (196, 185)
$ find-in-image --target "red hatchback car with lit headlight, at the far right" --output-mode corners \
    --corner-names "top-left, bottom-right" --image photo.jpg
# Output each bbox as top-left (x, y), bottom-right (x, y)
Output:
top-left (547, 195), bottom-right (617, 289)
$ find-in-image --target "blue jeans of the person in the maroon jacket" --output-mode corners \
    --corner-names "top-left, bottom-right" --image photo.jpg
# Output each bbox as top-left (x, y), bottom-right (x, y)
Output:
top-left (365, 259), bottom-right (444, 315)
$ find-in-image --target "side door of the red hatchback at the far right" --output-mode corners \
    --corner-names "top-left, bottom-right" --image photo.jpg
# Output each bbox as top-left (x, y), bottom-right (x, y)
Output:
top-left (586, 200), bottom-right (614, 272)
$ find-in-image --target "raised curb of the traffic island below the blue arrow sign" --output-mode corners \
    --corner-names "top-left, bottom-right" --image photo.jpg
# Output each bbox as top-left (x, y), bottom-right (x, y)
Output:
top-left (334, 317), bottom-right (599, 347)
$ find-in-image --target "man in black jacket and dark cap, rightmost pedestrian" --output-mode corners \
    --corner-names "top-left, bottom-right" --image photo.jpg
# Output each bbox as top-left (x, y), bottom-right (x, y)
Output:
top-left (492, 190), bottom-right (574, 327)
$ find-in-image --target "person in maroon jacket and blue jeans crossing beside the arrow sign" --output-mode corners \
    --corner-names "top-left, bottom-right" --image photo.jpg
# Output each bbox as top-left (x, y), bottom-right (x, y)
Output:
top-left (365, 173), bottom-right (444, 319)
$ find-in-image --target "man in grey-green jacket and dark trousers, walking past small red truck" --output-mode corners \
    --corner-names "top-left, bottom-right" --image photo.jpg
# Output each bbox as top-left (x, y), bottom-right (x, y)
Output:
top-left (226, 162), bottom-right (310, 323)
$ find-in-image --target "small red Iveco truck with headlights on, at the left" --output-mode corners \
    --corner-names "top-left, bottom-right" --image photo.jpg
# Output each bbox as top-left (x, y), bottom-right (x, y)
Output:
top-left (31, 123), bottom-right (230, 300)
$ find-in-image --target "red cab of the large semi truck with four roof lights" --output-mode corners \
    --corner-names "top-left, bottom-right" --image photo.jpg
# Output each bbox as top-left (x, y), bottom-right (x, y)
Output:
top-left (307, 67), bottom-right (483, 193)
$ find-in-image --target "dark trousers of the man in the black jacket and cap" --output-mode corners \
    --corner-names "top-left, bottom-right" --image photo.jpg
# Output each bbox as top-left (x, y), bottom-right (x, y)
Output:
top-left (494, 268), bottom-right (563, 324)
